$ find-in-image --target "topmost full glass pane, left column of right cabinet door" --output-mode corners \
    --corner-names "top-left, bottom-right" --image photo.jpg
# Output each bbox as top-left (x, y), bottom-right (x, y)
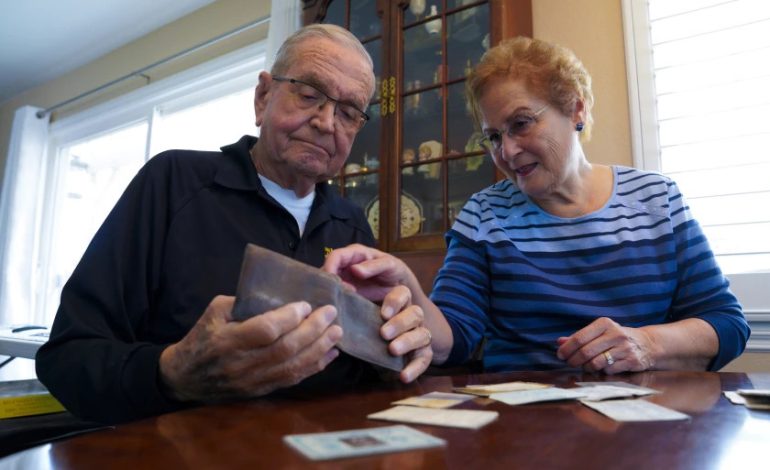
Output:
top-left (402, 19), bottom-right (442, 85)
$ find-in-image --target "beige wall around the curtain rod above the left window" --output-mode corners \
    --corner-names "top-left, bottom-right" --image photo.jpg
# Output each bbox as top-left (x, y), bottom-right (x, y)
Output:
top-left (0, 0), bottom-right (270, 191)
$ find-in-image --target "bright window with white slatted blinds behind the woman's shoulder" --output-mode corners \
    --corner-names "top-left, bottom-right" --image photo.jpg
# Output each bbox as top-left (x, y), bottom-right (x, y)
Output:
top-left (623, 0), bottom-right (770, 351)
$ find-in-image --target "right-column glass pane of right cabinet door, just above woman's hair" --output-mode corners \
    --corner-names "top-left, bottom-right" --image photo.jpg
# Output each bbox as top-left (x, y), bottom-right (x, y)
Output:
top-left (447, 4), bottom-right (489, 80)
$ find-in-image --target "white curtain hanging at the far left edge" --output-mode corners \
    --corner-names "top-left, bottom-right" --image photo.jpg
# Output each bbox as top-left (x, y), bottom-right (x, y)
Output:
top-left (0, 106), bottom-right (49, 325)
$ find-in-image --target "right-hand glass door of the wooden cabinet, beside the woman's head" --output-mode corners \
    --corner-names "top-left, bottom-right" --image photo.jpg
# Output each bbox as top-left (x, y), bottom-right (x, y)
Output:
top-left (394, 0), bottom-right (496, 248)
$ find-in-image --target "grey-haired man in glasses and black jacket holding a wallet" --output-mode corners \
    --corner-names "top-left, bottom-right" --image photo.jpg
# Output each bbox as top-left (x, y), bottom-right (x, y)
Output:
top-left (37, 25), bottom-right (432, 422)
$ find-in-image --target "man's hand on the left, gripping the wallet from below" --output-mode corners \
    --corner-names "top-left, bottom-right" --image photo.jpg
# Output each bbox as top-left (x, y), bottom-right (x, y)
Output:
top-left (160, 296), bottom-right (342, 402)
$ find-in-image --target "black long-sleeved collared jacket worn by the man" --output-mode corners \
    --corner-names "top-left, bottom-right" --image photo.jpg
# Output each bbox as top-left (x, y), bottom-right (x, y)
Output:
top-left (36, 136), bottom-right (376, 423)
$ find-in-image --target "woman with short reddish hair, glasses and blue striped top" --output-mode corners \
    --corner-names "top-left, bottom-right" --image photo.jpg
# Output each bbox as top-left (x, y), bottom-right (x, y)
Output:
top-left (326, 37), bottom-right (749, 374)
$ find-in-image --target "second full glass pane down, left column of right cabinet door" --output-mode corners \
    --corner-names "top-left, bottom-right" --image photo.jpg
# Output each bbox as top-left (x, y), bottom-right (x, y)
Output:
top-left (401, 89), bottom-right (444, 161)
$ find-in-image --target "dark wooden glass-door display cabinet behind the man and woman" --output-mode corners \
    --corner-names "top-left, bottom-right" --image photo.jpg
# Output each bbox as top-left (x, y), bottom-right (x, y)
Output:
top-left (303, 0), bottom-right (532, 291)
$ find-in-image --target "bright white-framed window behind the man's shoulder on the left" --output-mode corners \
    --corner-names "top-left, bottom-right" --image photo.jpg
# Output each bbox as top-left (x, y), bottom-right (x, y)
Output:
top-left (29, 43), bottom-right (265, 324)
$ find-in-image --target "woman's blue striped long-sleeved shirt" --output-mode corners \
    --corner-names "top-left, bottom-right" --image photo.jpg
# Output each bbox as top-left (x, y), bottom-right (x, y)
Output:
top-left (431, 166), bottom-right (749, 371)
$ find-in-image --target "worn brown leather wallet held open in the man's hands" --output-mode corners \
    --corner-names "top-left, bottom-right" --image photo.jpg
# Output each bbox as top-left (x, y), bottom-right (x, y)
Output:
top-left (233, 243), bottom-right (404, 371)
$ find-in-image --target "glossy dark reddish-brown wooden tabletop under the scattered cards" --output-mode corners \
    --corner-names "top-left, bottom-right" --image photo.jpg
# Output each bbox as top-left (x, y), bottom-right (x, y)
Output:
top-left (0, 372), bottom-right (770, 470)
